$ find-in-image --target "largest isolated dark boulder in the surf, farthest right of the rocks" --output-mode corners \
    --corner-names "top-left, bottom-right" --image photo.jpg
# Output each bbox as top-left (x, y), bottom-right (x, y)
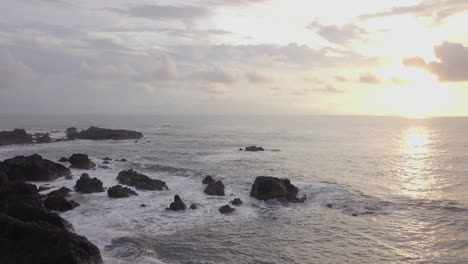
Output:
top-left (250, 176), bottom-right (306, 203)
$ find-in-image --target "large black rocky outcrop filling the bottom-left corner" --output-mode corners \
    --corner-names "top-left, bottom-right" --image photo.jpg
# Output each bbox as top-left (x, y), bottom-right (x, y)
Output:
top-left (0, 182), bottom-right (102, 264)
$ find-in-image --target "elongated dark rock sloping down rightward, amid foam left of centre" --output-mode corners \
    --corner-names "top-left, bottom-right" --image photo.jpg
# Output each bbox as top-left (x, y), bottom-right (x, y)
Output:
top-left (117, 169), bottom-right (169, 191)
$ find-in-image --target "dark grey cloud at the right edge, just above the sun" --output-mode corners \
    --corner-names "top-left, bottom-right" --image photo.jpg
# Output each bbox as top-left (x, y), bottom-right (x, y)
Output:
top-left (403, 42), bottom-right (468, 82)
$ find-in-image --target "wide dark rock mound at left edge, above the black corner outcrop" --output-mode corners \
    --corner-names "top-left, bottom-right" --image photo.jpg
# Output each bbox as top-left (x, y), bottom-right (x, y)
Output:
top-left (0, 154), bottom-right (71, 181)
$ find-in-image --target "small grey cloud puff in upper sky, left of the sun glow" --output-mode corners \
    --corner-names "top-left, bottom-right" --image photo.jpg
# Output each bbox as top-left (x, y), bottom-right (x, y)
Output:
top-left (307, 22), bottom-right (367, 45)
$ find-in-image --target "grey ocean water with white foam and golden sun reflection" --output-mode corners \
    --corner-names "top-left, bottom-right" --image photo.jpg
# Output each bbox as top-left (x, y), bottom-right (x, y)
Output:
top-left (0, 115), bottom-right (468, 264)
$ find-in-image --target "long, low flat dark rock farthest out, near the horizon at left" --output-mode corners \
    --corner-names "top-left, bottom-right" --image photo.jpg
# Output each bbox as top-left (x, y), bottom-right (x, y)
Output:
top-left (78, 127), bottom-right (143, 140)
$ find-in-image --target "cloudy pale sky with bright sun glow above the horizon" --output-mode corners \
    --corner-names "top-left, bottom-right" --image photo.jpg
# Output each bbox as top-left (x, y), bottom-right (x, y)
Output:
top-left (0, 0), bottom-right (468, 118)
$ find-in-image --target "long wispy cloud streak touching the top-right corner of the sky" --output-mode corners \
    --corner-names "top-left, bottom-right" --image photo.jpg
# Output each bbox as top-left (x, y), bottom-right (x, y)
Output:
top-left (360, 0), bottom-right (468, 22)
